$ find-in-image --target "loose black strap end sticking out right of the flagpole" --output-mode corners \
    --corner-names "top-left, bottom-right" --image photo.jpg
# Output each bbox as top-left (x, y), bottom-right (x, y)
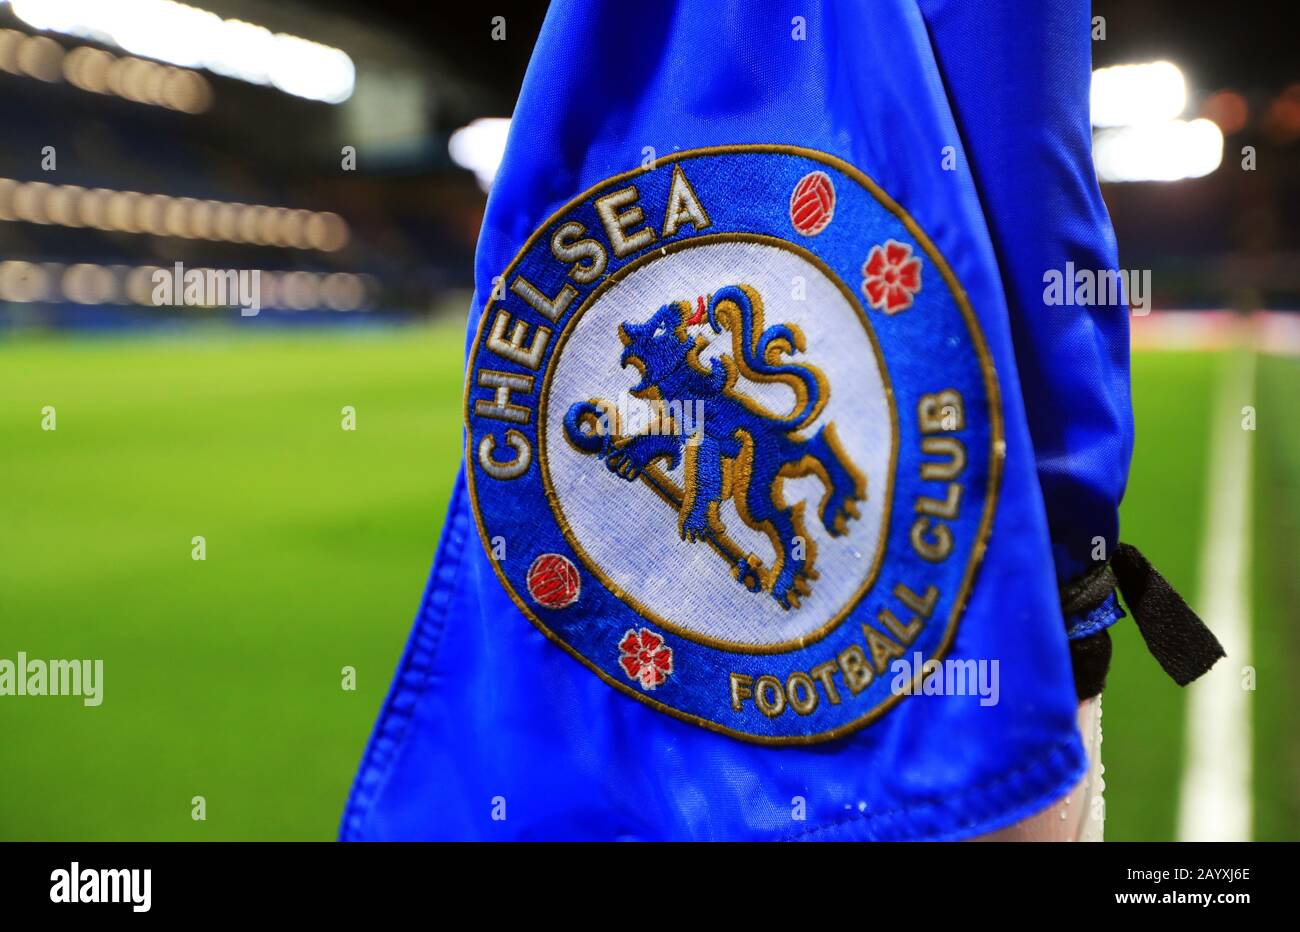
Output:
top-left (1110, 543), bottom-right (1226, 686)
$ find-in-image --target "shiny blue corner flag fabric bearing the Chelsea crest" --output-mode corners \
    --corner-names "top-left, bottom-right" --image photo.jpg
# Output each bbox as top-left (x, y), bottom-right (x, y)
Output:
top-left (341, 0), bottom-right (1131, 840)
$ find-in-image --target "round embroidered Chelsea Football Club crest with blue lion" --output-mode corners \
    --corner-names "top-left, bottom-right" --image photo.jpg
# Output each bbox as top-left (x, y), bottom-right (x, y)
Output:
top-left (465, 146), bottom-right (1004, 744)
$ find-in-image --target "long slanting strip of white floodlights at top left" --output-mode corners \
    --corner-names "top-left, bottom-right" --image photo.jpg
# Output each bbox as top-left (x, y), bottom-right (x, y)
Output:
top-left (10, 0), bottom-right (356, 104)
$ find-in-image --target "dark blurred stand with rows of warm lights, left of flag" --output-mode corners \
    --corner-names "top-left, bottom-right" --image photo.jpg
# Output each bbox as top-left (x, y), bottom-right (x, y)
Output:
top-left (0, 0), bottom-right (517, 328)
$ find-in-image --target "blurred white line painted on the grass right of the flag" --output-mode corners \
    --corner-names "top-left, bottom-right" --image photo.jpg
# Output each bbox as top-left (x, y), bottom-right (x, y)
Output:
top-left (1178, 347), bottom-right (1255, 841)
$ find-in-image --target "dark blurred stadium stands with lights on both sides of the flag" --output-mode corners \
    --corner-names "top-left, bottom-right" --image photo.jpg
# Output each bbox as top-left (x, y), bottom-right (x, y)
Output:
top-left (0, 0), bottom-right (1300, 330)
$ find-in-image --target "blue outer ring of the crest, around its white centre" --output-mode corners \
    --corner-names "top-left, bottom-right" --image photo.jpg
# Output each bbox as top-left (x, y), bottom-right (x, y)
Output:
top-left (465, 146), bottom-right (1004, 744)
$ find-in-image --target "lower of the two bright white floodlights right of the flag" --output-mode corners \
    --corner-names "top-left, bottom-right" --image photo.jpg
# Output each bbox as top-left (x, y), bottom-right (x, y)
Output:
top-left (1092, 120), bottom-right (1223, 181)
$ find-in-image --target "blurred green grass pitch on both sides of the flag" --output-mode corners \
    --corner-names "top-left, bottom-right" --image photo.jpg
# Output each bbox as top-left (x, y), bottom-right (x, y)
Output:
top-left (0, 325), bottom-right (1300, 840)
